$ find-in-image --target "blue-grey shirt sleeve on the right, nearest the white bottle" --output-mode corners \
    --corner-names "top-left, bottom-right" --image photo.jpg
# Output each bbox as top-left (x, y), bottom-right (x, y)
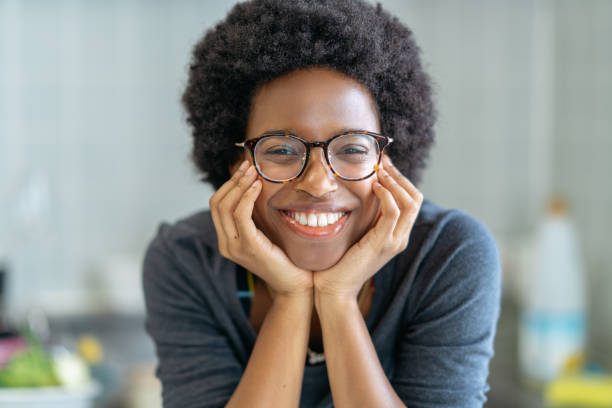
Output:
top-left (391, 213), bottom-right (501, 408)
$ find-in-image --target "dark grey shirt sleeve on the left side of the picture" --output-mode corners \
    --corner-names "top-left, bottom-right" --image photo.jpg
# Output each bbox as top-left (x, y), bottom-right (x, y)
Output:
top-left (143, 233), bottom-right (243, 408)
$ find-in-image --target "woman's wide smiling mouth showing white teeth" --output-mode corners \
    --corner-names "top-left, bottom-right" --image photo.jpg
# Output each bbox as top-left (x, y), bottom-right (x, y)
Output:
top-left (280, 210), bottom-right (350, 239)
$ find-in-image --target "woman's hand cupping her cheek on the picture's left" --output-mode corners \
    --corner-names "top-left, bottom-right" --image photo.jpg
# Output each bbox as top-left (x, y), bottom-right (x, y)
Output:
top-left (209, 161), bottom-right (313, 295)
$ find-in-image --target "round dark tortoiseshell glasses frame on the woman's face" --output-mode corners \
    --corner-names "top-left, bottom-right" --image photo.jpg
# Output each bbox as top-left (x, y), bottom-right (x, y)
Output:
top-left (234, 131), bottom-right (393, 184)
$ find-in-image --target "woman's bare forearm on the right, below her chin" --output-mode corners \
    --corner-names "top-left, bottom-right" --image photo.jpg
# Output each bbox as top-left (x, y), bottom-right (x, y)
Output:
top-left (315, 291), bottom-right (404, 408)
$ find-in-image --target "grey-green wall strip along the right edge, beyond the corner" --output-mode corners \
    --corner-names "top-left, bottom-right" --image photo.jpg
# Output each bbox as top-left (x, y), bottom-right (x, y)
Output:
top-left (553, 0), bottom-right (612, 365)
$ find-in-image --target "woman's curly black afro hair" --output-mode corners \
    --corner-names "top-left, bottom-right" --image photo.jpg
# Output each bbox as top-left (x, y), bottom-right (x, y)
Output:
top-left (183, 0), bottom-right (436, 188)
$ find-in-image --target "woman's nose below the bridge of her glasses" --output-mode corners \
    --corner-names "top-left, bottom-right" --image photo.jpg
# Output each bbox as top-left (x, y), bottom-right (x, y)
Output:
top-left (295, 148), bottom-right (338, 198)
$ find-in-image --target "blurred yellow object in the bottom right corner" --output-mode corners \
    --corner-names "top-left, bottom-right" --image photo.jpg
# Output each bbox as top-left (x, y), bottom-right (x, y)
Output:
top-left (544, 374), bottom-right (612, 408)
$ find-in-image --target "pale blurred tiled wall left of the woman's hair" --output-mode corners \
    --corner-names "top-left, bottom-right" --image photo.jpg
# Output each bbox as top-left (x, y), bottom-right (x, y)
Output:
top-left (0, 0), bottom-right (231, 313)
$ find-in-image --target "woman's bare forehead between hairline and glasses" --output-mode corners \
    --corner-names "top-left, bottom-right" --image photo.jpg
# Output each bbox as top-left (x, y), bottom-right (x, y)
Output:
top-left (247, 68), bottom-right (380, 140)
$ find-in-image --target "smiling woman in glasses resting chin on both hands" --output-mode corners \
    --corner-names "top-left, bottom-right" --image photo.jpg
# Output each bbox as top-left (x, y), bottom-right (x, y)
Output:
top-left (143, 0), bottom-right (501, 408)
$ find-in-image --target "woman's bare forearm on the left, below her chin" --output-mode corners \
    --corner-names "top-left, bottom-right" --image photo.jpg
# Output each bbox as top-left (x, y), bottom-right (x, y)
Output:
top-left (227, 292), bottom-right (313, 407)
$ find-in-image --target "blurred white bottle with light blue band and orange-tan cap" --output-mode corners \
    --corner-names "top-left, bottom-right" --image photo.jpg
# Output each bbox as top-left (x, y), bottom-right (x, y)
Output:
top-left (519, 197), bottom-right (587, 385)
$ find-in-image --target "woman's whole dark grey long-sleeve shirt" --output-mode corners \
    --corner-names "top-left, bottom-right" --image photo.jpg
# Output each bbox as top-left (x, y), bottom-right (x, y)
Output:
top-left (143, 200), bottom-right (501, 408)
